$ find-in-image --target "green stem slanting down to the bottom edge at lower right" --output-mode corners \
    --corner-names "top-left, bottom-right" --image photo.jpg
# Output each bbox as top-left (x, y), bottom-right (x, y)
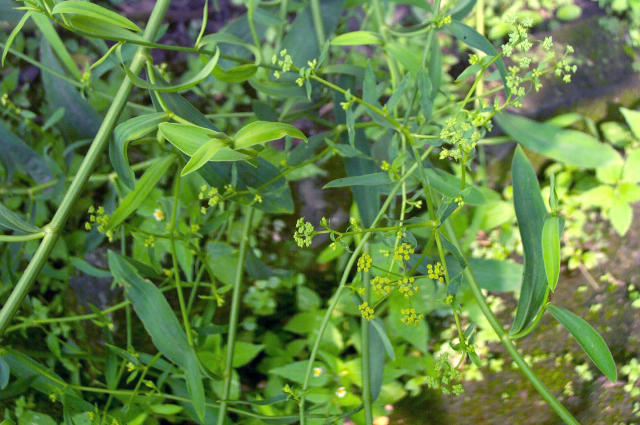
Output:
top-left (445, 220), bottom-right (580, 425)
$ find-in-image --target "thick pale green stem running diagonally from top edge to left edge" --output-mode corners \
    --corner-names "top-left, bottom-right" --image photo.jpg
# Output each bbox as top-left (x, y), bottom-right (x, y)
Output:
top-left (0, 0), bottom-right (170, 338)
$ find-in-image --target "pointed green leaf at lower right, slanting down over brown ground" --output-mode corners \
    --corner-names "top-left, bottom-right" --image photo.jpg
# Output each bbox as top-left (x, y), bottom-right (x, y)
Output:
top-left (547, 304), bottom-right (618, 382)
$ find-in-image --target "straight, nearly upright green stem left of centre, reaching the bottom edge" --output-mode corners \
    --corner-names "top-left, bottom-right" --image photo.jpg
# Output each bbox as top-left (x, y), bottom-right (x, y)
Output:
top-left (217, 207), bottom-right (253, 425)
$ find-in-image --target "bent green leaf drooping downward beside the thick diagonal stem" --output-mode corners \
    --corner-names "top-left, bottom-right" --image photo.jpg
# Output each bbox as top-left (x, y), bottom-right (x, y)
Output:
top-left (109, 112), bottom-right (169, 189)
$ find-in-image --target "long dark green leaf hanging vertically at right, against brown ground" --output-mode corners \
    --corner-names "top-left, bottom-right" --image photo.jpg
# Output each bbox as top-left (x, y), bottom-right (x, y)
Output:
top-left (511, 146), bottom-right (547, 334)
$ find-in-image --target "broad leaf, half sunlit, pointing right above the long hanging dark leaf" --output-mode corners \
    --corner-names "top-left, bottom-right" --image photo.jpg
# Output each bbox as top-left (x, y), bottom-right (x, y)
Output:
top-left (495, 112), bottom-right (620, 168)
